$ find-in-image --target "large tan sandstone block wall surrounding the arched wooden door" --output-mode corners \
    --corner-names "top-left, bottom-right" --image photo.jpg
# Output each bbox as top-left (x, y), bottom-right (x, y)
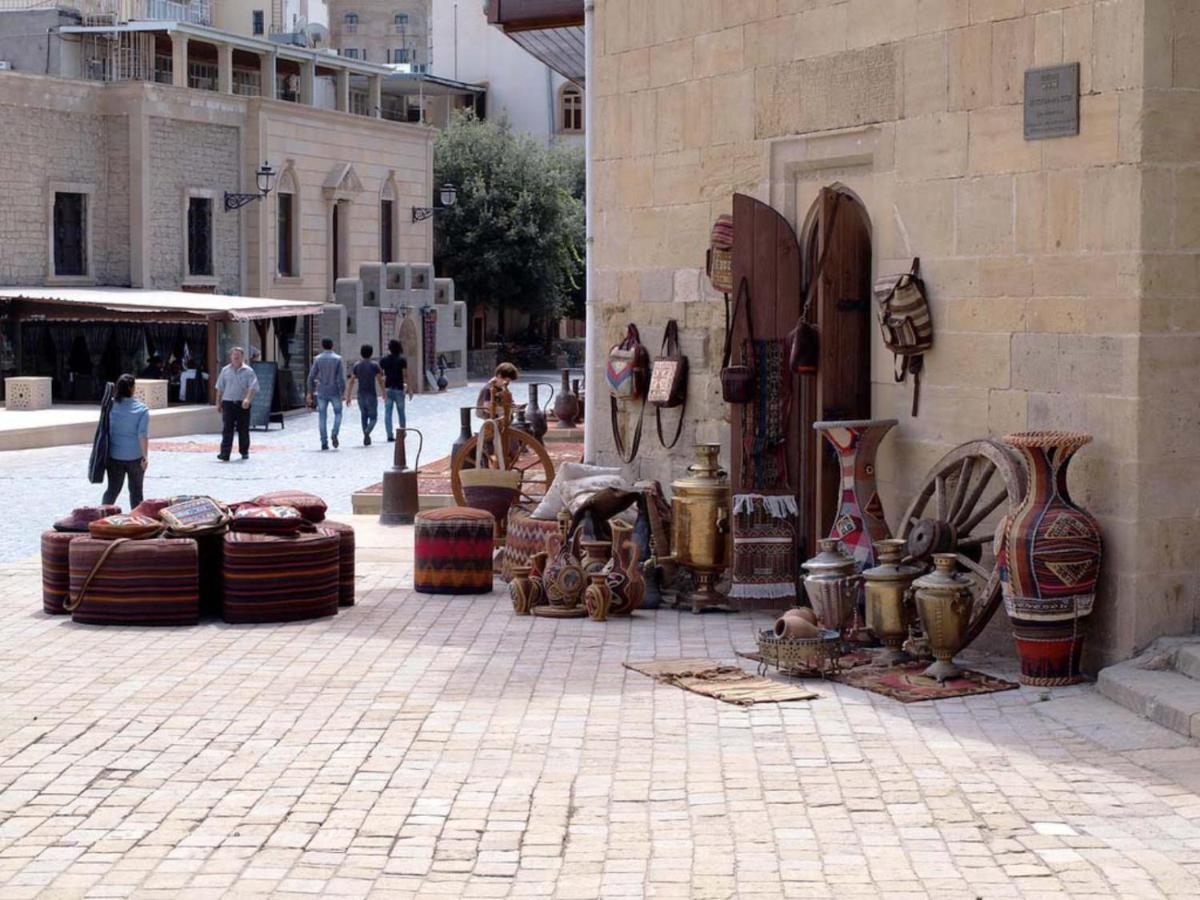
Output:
top-left (588, 0), bottom-right (1200, 665)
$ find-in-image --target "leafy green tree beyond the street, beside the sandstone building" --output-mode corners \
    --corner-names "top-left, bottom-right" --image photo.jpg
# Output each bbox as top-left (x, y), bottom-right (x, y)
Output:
top-left (433, 112), bottom-right (584, 338)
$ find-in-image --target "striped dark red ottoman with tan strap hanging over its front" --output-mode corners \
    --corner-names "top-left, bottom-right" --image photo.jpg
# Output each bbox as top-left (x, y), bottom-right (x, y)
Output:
top-left (66, 538), bottom-right (200, 625)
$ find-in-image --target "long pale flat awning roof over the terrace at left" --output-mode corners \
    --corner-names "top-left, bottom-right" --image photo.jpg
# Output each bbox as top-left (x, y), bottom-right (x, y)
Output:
top-left (0, 287), bottom-right (325, 322)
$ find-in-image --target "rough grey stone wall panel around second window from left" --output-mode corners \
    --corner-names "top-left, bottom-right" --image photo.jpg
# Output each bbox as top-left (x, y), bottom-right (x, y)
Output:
top-left (144, 116), bottom-right (241, 294)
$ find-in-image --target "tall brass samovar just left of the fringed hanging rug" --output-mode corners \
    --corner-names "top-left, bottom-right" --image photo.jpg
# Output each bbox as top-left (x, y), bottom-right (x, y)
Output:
top-left (648, 444), bottom-right (732, 612)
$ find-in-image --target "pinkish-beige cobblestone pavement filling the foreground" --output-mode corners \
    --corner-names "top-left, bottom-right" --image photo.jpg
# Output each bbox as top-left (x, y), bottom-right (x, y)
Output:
top-left (0, 520), bottom-right (1200, 900)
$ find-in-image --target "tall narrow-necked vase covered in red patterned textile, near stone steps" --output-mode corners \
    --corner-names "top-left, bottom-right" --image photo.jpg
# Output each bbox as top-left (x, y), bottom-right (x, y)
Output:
top-left (1002, 431), bottom-right (1102, 686)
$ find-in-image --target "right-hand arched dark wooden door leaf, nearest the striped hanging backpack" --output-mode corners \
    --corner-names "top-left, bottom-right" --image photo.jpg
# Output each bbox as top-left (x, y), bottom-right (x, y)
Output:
top-left (800, 184), bottom-right (872, 551)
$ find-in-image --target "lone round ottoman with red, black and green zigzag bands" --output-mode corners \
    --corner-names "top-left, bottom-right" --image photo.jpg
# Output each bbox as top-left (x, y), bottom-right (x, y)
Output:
top-left (413, 506), bottom-right (496, 594)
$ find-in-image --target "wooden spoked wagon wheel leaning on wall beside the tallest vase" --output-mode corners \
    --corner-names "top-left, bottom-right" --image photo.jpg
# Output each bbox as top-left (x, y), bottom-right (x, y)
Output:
top-left (899, 440), bottom-right (1026, 643)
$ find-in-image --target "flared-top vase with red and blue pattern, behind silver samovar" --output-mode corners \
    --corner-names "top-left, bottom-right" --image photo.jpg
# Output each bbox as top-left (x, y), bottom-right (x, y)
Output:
top-left (812, 419), bottom-right (896, 571)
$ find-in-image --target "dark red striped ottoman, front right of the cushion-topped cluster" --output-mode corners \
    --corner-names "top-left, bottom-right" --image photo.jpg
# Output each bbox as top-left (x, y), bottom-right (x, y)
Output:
top-left (221, 532), bottom-right (338, 623)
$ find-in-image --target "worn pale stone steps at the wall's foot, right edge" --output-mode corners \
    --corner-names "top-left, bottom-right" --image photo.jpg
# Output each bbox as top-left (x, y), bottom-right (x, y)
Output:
top-left (1096, 638), bottom-right (1200, 740)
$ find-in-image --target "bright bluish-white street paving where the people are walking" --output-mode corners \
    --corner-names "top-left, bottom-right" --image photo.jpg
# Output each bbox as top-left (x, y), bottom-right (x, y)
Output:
top-left (0, 383), bottom-right (492, 560)
